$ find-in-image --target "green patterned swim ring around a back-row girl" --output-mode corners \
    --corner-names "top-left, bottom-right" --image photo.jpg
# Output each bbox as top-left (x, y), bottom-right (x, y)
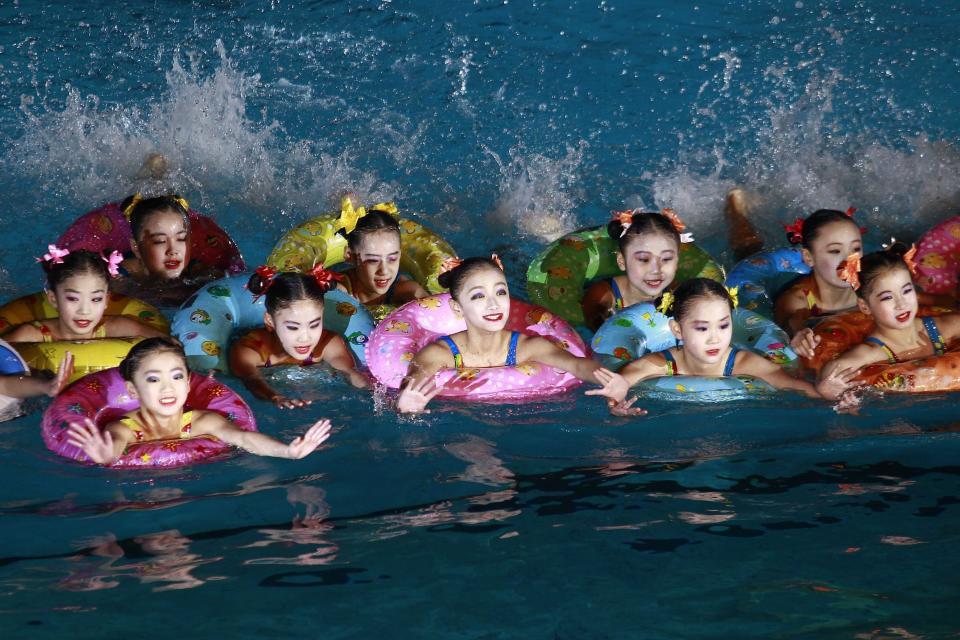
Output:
top-left (527, 226), bottom-right (723, 326)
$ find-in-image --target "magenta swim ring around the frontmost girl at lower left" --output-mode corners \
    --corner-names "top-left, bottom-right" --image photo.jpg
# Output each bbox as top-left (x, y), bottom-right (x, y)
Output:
top-left (40, 368), bottom-right (257, 468)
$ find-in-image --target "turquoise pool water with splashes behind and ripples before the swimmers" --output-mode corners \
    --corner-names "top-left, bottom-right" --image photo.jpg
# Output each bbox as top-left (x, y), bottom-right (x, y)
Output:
top-left (0, 0), bottom-right (960, 639)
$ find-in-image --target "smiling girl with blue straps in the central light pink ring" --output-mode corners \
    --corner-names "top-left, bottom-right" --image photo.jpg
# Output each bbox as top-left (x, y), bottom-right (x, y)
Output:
top-left (397, 256), bottom-right (613, 413)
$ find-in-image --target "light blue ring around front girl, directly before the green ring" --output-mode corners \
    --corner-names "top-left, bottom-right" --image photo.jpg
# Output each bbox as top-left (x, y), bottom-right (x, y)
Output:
top-left (590, 302), bottom-right (797, 371)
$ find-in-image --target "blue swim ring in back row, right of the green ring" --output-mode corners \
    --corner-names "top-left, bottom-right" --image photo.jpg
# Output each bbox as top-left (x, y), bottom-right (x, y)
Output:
top-left (726, 247), bottom-right (810, 316)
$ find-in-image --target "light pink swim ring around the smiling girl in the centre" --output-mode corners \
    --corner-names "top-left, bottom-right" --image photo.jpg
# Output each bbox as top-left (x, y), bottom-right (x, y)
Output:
top-left (367, 293), bottom-right (586, 401)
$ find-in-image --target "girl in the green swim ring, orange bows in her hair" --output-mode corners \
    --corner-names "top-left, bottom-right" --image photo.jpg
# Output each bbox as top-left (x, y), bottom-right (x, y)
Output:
top-left (582, 209), bottom-right (688, 331)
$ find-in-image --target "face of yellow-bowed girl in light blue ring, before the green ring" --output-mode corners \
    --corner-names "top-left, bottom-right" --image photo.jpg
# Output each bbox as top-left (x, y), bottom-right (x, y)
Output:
top-left (670, 296), bottom-right (733, 364)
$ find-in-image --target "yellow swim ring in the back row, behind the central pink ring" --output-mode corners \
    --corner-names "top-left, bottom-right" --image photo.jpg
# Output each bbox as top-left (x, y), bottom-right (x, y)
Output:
top-left (267, 203), bottom-right (457, 308)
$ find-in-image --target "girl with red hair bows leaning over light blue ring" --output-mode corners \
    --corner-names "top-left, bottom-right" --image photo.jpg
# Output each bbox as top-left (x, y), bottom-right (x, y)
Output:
top-left (230, 265), bottom-right (368, 409)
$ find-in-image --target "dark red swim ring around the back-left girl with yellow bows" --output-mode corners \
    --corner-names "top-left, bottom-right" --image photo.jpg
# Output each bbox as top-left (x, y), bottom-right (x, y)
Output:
top-left (56, 202), bottom-right (247, 273)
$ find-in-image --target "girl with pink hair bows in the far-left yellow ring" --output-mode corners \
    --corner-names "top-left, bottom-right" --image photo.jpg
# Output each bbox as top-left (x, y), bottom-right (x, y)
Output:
top-left (6, 245), bottom-right (163, 342)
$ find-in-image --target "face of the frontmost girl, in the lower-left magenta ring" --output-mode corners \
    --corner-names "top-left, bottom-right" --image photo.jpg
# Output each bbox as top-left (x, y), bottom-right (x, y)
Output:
top-left (127, 351), bottom-right (190, 417)
